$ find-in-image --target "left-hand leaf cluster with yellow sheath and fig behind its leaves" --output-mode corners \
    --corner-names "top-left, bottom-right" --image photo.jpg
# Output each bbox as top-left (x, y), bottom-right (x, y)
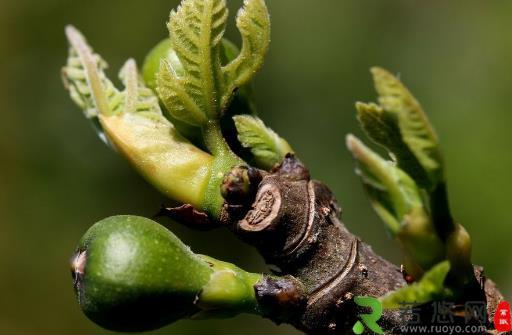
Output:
top-left (63, 0), bottom-right (292, 218)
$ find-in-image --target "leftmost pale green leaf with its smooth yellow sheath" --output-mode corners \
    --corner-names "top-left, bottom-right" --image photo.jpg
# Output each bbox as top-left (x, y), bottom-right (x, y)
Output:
top-left (63, 27), bottom-right (213, 208)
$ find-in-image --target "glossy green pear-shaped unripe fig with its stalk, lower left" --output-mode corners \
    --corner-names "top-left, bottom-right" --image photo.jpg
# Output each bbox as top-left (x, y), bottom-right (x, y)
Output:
top-left (71, 216), bottom-right (262, 331)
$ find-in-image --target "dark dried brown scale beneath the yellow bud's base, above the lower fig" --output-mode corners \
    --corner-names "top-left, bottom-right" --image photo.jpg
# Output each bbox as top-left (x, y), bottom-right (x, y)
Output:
top-left (156, 204), bottom-right (219, 230)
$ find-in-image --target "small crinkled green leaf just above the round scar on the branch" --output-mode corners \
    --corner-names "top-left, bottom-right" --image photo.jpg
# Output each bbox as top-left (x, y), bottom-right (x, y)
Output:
top-left (233, 115), bottom-right (293, 170)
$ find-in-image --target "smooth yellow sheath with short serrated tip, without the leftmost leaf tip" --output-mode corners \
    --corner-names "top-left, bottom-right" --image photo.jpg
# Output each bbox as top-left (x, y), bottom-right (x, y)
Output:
top-left (100, 61), bottom-right (213, 208)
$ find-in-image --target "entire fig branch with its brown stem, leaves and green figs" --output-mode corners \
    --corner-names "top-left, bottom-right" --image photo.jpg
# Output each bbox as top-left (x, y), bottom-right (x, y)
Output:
top-left (62, 0), bottom-right (503, 334)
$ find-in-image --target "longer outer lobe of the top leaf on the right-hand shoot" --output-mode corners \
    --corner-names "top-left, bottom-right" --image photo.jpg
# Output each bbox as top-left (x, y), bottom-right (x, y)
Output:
top-left (371, 67), bottom-right (444, 191)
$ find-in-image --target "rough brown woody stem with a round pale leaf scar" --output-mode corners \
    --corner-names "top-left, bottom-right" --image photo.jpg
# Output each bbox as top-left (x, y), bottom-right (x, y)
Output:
top-left (209, 156), bottom-right (503, 334)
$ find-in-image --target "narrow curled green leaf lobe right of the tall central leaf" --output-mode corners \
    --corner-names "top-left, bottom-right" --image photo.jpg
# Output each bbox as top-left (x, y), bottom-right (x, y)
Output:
top-left (221, 0), bottom-right (270, 109)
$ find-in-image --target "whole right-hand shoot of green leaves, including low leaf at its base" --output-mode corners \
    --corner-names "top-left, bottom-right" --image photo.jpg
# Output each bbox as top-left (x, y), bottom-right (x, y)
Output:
top-left (347, 68), bottom-right (471, 305)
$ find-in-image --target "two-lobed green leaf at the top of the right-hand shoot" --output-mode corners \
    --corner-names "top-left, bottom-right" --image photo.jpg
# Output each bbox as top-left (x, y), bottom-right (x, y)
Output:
top-left (358, 67), bottom-right (444, 191)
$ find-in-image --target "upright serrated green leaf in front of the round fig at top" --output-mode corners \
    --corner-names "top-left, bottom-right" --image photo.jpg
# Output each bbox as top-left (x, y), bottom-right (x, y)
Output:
top-left (157, 0), bottom-right (228, 126)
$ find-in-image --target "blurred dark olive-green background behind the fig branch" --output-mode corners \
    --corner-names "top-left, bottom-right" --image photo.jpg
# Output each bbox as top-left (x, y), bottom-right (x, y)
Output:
top-left (0, 0), bottom-right (512, 335)
